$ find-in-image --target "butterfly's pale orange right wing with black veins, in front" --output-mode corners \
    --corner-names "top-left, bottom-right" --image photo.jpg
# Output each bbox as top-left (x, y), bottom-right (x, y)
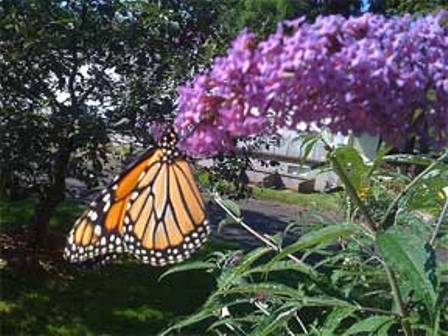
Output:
top-left (124, 159), bottom-right (210, 266)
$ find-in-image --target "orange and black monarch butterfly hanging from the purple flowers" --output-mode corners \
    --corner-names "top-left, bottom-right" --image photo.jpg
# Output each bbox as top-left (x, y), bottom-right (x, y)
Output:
top-left (64, 131), bottom-right (210, 266)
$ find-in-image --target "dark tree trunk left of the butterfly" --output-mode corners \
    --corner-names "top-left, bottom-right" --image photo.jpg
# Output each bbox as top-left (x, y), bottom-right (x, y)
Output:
top-left (33, 147), bottom-right (71, 246)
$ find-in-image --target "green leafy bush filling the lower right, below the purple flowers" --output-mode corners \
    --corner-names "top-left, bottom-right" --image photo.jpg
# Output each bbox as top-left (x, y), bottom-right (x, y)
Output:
top-left (161, 142), bottom-right (448, 335)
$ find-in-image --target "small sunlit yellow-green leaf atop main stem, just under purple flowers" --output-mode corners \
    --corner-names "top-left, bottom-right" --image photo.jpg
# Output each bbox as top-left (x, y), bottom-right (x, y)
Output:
top-left (334, 146), bottom-right (369, 190)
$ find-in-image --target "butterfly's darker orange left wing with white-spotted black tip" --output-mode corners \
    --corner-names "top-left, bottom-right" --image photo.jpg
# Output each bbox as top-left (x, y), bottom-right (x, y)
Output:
top-left (64, 150), bottom-right (161, 264)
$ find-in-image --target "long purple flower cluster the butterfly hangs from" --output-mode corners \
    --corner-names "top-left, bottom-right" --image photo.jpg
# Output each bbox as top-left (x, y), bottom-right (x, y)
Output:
top-left (175, 11), bottom-right (448, 155)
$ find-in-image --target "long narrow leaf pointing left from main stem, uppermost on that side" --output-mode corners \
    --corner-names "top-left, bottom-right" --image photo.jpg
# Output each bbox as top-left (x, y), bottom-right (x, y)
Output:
top-left (269, 224), bottom-right (358, 265)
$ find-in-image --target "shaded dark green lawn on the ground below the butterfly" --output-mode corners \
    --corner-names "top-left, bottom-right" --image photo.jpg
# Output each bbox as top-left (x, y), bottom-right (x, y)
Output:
top-left (0, 200), bottom-right (236, 335)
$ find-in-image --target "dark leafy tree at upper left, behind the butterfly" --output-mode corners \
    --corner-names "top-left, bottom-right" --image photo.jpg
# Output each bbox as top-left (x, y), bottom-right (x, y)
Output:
top-left (0, 0), bottom-right (219, 242)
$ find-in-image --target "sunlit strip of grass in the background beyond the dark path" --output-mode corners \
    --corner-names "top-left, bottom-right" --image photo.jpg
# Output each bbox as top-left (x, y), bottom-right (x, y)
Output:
top-left (253, 187), bottom-right (341, 211)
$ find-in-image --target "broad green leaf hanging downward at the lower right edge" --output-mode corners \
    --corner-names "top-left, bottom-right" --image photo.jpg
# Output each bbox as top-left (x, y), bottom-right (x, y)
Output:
top-left (377, 230), bottom-right (437, 315)
